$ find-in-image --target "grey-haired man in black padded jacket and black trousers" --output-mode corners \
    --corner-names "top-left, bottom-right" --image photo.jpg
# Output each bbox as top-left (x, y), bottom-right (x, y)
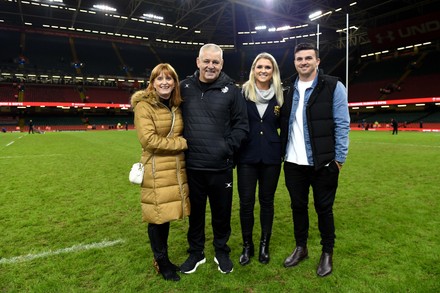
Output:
top-left (180, 44), bottom-right (249, 274)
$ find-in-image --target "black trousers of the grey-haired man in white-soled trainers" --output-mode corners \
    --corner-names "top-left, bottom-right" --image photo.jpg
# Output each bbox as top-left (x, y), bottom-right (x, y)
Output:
top-left (186, 169), bottom-right (232, 253)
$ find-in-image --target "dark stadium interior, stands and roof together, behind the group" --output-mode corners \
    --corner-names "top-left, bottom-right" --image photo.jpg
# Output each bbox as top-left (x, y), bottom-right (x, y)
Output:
top-left (0, 0), bottom-right (440, 131)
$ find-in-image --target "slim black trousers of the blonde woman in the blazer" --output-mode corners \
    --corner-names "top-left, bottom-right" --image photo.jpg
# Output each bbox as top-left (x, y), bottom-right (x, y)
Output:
top-left (237, 163), bottom-right (281, 242)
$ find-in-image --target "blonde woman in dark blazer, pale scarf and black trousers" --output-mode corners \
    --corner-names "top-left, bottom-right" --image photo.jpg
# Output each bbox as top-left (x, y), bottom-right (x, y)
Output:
top-left (237, 53), bottom-right (284, 265)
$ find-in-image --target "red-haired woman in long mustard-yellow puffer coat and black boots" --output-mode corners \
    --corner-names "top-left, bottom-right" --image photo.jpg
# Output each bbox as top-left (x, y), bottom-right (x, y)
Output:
top-left (131, 63), bottom-right (190, 281)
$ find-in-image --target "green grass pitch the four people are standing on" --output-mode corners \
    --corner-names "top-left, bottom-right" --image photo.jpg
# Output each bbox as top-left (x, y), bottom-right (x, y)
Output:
top-left (0, 131), bottom-right (440, 292)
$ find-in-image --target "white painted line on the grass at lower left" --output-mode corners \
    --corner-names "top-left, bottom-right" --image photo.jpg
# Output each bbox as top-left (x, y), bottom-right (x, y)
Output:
top-left (0, 239), bottom-right (125, 264)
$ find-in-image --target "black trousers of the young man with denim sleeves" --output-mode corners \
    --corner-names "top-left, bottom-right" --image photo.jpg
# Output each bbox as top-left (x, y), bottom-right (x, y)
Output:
top-left (284, 161), bottom-right (339, 252)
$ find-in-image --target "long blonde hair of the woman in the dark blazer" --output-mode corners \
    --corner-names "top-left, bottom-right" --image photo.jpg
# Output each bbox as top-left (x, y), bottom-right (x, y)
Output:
top-left (243, 52), bottom-right (284, 107)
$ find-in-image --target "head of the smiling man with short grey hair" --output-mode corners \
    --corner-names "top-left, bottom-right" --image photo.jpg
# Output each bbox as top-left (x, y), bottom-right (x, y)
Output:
top-left (196, 48), bottom-right (223, 83)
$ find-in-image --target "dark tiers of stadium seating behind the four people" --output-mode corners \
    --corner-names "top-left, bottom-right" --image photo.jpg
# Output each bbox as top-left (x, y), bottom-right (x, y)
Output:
top-left (0, 31), bottom-right (440, 130)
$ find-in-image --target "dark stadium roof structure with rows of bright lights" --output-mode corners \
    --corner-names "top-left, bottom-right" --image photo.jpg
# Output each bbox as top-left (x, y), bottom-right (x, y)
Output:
top-left (0, 0), bottom-right (440, 49)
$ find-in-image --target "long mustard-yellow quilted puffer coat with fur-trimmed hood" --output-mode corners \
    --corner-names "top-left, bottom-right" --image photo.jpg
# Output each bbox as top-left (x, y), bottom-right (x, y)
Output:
top-left (131, 91), bottom-right (190, 224)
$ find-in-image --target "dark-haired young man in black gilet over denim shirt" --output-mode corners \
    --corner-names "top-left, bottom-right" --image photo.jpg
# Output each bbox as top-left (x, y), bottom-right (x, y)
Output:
top-left (280, 43), bottom-right (350, 277)
